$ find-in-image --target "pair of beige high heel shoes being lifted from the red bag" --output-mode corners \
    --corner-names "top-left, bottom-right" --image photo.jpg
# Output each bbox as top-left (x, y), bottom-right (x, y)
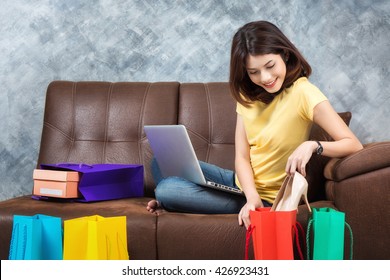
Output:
top-left (271, 172), bottom-right (311, 212)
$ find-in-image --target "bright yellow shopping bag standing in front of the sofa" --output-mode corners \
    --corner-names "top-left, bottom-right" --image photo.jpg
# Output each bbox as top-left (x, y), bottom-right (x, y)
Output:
top-left (64, 215), bottom-right (129, 260)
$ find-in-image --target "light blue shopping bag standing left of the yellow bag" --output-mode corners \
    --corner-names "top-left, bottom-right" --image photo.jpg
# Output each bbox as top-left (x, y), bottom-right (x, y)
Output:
top-left (9, 214), bottom-right (63, 260)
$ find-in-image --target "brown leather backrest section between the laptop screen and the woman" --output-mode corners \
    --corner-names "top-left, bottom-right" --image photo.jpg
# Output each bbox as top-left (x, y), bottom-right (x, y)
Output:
top-left (178, 83), bottom-right (236, 170)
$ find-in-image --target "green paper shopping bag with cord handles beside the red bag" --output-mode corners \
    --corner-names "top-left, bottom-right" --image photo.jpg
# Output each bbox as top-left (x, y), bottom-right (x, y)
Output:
top-left (306, 207), bottom-right (353, 260)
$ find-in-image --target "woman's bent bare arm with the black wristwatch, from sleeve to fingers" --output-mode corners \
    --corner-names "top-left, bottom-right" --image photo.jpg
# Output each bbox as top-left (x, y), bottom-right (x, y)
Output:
top-left (286, 101), bottom-right (363, 176)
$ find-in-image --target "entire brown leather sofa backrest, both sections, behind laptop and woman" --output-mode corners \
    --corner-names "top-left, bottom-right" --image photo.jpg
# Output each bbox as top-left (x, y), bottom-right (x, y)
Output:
top-left (38, 81), bottom-right (350, 201)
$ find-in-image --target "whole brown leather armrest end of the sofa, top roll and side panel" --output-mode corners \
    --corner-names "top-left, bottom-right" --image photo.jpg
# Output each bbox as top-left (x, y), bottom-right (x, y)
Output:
top-left (324, 141), bottom-right (390, 259)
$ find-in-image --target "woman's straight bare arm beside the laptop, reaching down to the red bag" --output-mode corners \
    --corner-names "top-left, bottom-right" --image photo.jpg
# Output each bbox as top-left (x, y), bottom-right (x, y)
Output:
top-left (235, 115), bottom-right (263, 228)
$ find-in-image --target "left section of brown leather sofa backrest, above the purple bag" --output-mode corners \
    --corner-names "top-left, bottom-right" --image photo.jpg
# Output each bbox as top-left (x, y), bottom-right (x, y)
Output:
top-left (38, 81), bottom-right (179, 195)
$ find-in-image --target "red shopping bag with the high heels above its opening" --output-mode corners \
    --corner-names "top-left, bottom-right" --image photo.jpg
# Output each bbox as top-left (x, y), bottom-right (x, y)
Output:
top-left (245, 207), bottom-right (303, 260)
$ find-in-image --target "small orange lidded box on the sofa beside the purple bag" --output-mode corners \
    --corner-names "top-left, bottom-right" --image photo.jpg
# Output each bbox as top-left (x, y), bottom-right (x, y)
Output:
top-left (33, 169), bottom-right (80, 198)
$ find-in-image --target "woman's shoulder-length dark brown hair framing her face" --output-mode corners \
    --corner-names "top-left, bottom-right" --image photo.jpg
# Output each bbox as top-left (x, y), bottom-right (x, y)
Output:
top-left (229, 21), bottom-right (311, 106)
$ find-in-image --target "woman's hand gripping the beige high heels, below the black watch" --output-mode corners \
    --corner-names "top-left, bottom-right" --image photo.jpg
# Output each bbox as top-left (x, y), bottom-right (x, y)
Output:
top-left (286, 141), bottom-right (318, 177)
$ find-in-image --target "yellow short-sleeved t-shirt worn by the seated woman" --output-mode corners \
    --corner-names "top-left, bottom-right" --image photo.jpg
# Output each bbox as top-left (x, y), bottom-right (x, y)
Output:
top-left (236, 77), bottom-right (327, 203)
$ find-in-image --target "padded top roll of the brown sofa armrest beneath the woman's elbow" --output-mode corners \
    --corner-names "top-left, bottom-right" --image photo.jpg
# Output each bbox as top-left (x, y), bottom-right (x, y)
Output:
top-left (324, 141), bottom-right (390, 182)
